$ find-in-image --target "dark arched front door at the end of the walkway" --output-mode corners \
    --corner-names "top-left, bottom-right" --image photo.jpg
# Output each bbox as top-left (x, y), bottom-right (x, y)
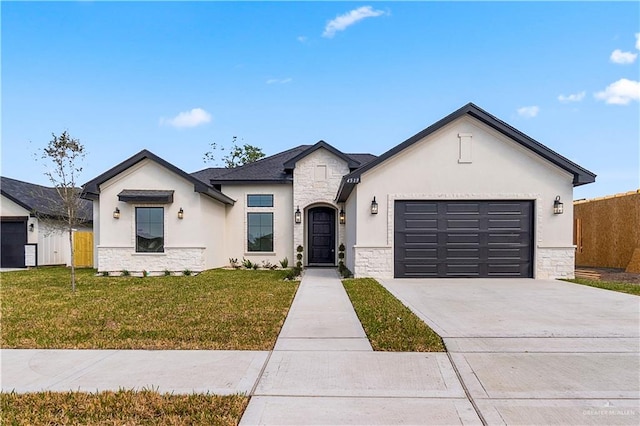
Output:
top-left (308, 207), bottom-right (336, 265)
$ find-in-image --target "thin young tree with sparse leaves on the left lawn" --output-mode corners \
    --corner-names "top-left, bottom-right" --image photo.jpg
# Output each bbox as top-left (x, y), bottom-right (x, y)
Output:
top-left (41, 130), bottom-right (87, 292)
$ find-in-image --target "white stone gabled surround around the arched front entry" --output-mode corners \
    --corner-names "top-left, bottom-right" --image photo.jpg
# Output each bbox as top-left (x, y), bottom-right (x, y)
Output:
top-left (291, 148), bottom-right (349, 264)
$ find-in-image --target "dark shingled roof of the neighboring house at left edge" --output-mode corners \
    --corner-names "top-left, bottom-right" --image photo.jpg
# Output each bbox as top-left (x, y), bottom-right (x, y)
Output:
top-left (0, 176), bottom-right (93, 222)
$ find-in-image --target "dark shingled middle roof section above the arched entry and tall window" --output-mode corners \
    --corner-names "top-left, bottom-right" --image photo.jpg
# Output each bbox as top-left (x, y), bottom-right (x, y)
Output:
top-left (192, 141), bottom-right (376, 185)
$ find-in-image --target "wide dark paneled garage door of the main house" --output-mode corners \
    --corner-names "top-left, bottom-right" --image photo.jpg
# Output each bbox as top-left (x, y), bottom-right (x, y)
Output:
top-left (394, 200), bottom-right (533, 278)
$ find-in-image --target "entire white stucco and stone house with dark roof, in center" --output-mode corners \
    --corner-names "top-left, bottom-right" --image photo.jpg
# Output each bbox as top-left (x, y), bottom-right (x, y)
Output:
top-left (84, 104), bottom-right (595, 278)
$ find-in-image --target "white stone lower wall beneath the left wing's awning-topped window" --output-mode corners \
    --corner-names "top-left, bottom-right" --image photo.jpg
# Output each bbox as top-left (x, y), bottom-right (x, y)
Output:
top-left (98, 247), bottom-right (205, 272)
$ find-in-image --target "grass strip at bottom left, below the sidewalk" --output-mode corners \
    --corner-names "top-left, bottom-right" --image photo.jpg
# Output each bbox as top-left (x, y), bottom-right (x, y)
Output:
top-left (0, 390), bottom-right (249, 425)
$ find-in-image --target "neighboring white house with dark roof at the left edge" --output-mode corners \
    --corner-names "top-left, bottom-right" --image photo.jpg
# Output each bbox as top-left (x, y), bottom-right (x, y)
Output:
top-left (0, 176), bottom-right (93, 268)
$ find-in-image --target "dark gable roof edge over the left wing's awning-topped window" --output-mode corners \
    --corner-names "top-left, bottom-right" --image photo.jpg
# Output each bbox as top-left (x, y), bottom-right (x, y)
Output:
top-left (82, 149), bottom-right (235, 205)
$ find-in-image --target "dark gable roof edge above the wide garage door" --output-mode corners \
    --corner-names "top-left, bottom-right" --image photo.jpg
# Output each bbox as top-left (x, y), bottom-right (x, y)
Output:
top-left (336, 103), bottom-right (596, 202)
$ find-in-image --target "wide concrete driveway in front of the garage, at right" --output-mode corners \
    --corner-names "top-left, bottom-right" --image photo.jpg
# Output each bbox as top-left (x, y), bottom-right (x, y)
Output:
top-left (382, 279), bottom-right (640, 424)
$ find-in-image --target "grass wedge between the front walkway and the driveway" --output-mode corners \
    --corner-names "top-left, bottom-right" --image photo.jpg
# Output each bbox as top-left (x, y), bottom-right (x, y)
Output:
top-left (343, 278), bottom-right (445, 352)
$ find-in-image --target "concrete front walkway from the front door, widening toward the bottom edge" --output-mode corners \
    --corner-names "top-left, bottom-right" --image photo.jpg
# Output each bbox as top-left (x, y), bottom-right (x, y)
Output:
top-left (240, 269), bottom-right (481, 425)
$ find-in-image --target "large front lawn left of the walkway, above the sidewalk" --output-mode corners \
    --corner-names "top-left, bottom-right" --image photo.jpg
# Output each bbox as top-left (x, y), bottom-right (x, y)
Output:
top-left (0, 268), bottom-right (298, 350)
